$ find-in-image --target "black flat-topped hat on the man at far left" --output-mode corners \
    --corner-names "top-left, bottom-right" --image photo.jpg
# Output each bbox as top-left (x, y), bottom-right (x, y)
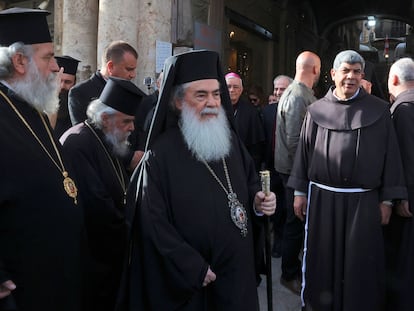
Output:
top-left (0, 8), bottom-right (52, 46)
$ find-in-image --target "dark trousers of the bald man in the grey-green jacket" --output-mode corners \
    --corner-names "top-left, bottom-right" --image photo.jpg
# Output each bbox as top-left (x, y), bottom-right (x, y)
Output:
top-left (280, 174), bottom-right (304, 281)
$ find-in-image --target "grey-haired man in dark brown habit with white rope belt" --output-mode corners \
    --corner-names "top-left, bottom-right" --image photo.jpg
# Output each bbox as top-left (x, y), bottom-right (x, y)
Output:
top-left (289, 50), bottom-right (407, 311)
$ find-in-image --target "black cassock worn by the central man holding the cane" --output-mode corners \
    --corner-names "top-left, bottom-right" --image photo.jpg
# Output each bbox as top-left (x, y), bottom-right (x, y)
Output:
top-left (125, 128), bottom-right (260, 311)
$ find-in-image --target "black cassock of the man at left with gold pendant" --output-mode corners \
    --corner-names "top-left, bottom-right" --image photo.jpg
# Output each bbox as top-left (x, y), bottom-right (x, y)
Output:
top-left (0, 85), bottom-right (84, 311)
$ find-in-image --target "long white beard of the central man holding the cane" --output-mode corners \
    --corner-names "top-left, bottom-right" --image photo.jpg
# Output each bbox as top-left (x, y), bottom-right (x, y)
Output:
top-left (180, 102), bottom-right (231, 162)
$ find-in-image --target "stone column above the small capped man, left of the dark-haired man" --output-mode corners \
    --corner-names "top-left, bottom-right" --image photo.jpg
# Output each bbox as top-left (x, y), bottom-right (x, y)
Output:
top-left (62, 0), bottom-right (98, 81)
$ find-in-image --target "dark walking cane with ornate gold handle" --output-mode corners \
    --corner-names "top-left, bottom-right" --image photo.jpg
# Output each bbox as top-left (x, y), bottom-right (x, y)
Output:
top-left (260, 171), bottom-right (273, 311)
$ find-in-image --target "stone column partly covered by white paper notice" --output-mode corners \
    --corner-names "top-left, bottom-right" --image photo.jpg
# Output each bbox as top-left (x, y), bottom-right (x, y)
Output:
top-left (136, 0), bottom-right (174, 88)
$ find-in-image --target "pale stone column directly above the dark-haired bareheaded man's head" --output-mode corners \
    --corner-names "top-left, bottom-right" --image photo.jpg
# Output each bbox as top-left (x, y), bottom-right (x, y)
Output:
top-left (97, 0), bottom-right (141, 77)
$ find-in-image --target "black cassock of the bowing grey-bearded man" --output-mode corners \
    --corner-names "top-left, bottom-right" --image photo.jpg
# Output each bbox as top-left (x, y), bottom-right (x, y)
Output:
top-left (61, 123), bottom-right (129, 311)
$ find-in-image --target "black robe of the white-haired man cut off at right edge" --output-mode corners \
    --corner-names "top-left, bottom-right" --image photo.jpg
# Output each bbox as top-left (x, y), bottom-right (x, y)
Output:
top-left (386, 89), bottom-right (414, 311)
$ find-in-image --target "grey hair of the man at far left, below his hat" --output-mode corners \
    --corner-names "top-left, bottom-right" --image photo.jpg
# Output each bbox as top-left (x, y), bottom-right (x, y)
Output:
top-left (0, 42), bottom-right (33, 80)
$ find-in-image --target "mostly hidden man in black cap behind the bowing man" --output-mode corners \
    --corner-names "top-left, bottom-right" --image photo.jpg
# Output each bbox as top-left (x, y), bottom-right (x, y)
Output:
top-left (50, 55), bottom-right (80, 138)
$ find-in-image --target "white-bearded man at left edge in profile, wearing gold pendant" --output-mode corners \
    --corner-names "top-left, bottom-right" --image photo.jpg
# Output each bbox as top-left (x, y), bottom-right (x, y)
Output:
top-left (0, 8), bottom-right (83, 311)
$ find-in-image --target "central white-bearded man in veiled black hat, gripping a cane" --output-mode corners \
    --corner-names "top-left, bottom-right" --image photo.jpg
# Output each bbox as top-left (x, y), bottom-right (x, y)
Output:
top-left (123, 51), bottom-right (276, 311)
